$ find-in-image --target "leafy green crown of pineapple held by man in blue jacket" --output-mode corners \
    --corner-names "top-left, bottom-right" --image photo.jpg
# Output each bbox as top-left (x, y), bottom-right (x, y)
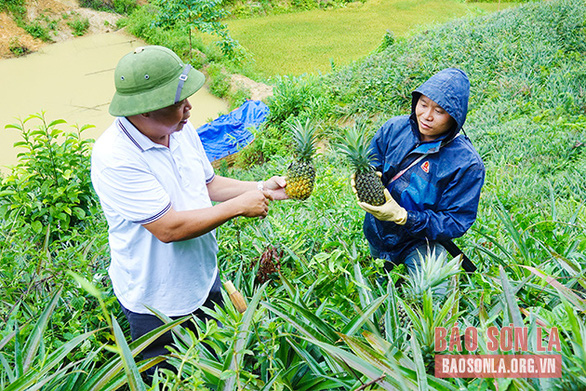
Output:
top-left (336, 125), bottom-right (374, 173)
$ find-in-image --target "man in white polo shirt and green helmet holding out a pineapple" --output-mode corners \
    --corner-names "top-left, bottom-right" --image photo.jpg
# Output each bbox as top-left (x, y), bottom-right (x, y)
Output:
top-left (91, 46), bottom-right (287, 374)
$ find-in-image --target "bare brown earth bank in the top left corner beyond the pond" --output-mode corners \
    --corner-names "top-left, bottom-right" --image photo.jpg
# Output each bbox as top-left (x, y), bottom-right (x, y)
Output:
top-left (0, 0), bottom-right (120, 58)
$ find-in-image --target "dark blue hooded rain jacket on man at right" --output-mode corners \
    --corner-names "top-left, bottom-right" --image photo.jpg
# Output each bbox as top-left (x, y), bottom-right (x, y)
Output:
top-left (364, 68), bottom-right (485, 263)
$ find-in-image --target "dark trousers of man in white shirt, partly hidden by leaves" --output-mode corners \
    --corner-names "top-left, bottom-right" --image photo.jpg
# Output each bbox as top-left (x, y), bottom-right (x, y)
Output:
top-left (120, 275), bottom-right (223, 377)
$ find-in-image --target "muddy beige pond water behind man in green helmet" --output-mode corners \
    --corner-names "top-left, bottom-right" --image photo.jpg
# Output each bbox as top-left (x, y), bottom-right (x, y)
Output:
top-left (0, 31), bottom-right (227, 172)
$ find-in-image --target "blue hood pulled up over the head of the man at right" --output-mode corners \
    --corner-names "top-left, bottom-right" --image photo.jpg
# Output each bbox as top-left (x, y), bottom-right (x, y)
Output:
top-left (411, 68), bottom-right (470, 139)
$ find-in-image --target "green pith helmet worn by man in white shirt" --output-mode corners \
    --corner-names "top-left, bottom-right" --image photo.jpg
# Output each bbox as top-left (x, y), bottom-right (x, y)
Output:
top-left (109, 46), bottom-right (205, 117)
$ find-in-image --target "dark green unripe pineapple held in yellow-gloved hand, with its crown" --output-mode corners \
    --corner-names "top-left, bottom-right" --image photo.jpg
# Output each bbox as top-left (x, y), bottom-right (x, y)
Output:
top-left (338, 126), bottom-right (386, 206)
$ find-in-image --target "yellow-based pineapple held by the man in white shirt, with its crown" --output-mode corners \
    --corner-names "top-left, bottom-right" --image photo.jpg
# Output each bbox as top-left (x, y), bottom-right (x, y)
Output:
top-left (285, 118), bottom-right (316, 200)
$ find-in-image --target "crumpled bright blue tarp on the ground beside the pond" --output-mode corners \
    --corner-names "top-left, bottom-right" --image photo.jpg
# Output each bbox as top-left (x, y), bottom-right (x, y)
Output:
top-left (197, 100), bottom-right (269, 162)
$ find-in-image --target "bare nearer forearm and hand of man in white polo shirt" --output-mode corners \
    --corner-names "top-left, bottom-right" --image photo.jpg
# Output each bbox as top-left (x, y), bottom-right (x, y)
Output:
top-left (143, 191), bottom-right (271, 243)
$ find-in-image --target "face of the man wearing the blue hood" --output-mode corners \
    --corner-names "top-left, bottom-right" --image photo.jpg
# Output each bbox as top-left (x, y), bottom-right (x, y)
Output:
top-left (415, 95), bottom-right (454, 141)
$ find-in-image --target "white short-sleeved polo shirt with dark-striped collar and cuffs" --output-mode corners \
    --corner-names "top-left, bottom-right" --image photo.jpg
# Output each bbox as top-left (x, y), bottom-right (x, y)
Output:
top-left (91, 117), bottom-right (218, 316)
